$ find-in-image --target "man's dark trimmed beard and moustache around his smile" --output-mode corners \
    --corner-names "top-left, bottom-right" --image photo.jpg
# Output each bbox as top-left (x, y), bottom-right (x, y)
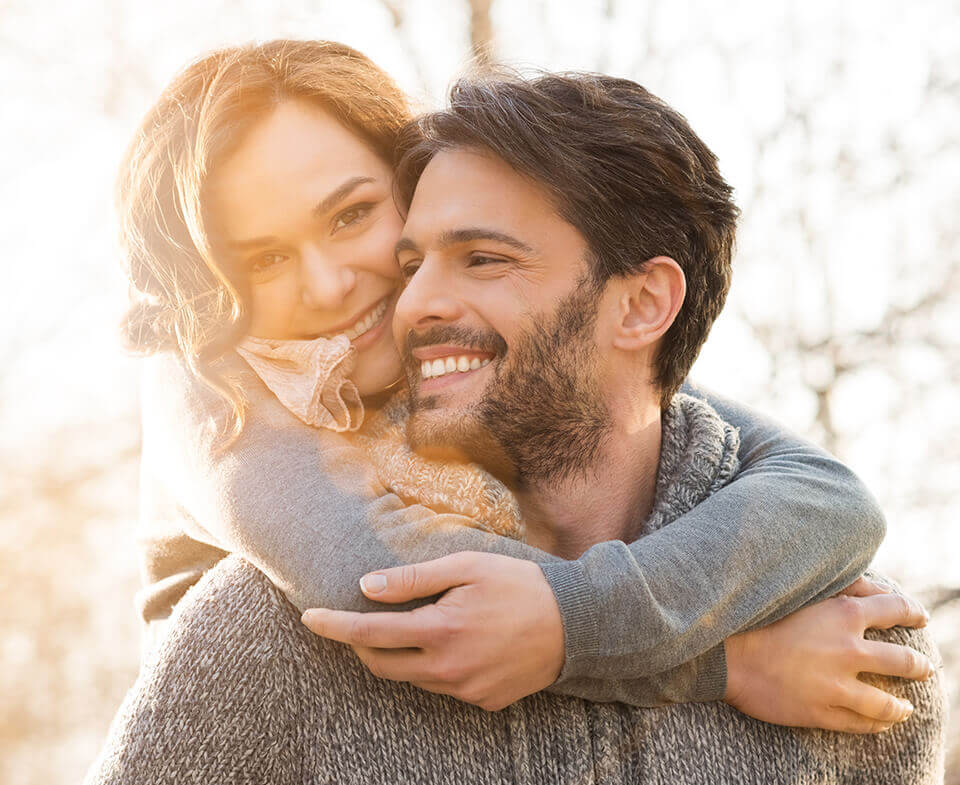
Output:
top-left (405, 282), bottom-right (612, 489)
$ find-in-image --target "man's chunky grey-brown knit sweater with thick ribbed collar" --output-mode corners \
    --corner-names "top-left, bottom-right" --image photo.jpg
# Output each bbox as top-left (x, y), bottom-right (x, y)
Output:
top-left (87, 399), bottom-right (944, 785)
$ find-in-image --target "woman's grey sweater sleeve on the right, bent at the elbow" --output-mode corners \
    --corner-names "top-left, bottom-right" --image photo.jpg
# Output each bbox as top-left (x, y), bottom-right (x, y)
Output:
top-left (541, 385), bottom-right (885, 705)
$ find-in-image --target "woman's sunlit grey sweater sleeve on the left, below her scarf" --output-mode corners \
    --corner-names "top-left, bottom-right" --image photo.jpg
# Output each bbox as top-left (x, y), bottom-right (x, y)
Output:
top-left (142, 356), bottom-right (559, 611)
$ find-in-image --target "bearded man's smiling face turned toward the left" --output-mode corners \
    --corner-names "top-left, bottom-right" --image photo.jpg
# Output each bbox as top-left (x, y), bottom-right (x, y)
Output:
top-left (394, 150), bottom-right (610, 483)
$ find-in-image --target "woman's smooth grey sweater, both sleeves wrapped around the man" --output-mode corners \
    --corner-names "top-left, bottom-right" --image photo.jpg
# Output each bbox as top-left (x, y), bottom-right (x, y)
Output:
top-left (144, 358), bottom-right (876, 706)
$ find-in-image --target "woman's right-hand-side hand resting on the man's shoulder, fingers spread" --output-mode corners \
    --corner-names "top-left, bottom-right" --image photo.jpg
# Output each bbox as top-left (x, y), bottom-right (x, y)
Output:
top-left (724, 578), bottom-right (933, 733)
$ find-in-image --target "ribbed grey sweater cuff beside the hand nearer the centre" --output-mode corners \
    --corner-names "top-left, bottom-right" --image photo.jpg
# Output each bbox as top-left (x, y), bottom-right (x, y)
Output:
top-left (539, 561), bottom-right (600, 684)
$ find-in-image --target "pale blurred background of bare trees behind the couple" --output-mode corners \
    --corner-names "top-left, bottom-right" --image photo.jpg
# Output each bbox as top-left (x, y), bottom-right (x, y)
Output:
top-left (0, 0), bottom-right (960, 785)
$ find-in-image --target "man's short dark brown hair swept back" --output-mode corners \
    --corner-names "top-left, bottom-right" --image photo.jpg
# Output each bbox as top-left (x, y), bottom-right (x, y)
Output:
top-left (396, 74), bottom-right (739, 406)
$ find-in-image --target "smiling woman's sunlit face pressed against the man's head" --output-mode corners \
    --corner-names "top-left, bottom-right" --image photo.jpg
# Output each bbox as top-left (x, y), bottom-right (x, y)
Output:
top-left (205, 100), bottom-right (403, 395)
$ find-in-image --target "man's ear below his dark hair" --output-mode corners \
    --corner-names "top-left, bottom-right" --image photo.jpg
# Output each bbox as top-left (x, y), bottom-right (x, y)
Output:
top-left (613, 256), bottom-right (687, 351)
